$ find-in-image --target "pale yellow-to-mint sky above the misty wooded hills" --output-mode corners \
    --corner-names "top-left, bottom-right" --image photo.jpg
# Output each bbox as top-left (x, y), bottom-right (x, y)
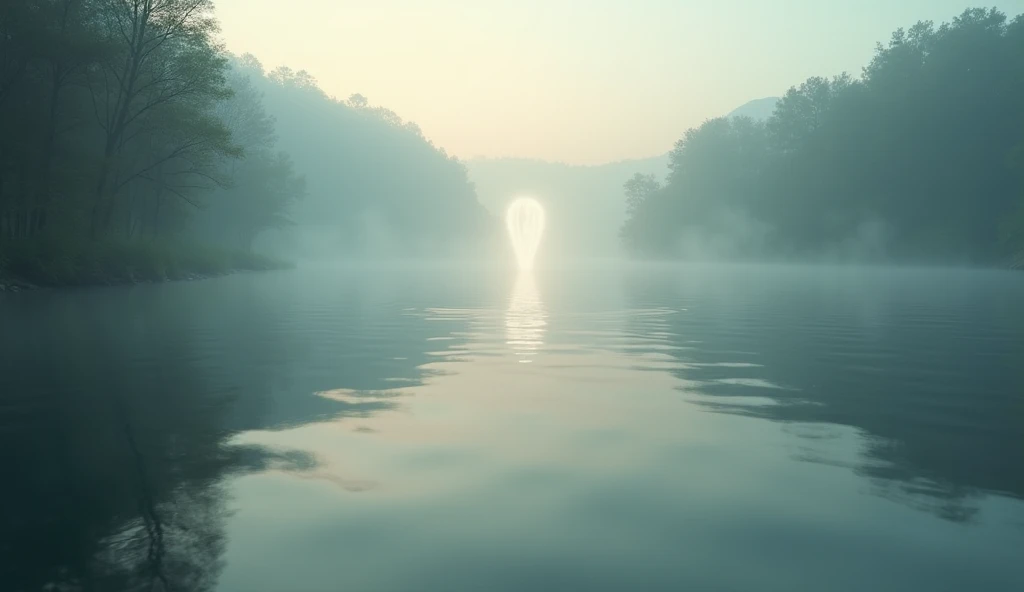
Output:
top-left (216, 0), bottom-right (1024, 164)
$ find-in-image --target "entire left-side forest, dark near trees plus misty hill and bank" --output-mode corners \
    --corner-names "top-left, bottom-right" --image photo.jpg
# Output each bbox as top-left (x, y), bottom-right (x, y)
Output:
top-left (0, 0), bottom-right (490, 284)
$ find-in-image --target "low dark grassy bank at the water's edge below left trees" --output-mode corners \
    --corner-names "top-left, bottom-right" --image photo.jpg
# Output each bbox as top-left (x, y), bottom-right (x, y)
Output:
top-left (0, 240), bottom-right (291, 292)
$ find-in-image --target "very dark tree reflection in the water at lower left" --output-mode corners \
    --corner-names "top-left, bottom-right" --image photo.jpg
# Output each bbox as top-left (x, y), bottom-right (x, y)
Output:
top-left (0, 285), bottom-right (403, 592)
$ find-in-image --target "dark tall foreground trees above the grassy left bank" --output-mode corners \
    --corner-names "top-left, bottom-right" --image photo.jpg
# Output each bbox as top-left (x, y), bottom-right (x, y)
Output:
top-left (0, 0), bottom-right (303, 247)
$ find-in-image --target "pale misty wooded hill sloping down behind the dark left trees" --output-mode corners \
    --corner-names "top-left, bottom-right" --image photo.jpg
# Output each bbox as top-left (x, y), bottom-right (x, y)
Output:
top-left (239, 55), bottom-right (500, 256)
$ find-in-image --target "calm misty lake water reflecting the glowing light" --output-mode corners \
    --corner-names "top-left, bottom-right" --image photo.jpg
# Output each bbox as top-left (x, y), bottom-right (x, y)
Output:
top-left (0, 266), bottom-right (1024, 592)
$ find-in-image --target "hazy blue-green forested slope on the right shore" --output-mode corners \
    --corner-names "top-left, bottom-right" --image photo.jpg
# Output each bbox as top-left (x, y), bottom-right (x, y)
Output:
top-left (621, 8), bottom-right (1024, 266)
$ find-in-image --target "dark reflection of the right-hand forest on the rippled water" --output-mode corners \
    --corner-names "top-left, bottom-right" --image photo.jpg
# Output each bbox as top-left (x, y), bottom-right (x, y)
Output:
top-left (629, 266), bottom-right (1024, 521)
